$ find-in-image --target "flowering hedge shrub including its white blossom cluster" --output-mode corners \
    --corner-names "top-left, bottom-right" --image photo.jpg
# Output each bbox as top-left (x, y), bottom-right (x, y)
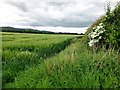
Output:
top-left (88, 3), bottom-right (120, 48)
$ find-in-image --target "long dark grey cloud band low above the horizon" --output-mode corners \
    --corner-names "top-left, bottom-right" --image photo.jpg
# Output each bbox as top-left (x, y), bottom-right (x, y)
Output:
top-left (25, 15), bottom-right (94, 27)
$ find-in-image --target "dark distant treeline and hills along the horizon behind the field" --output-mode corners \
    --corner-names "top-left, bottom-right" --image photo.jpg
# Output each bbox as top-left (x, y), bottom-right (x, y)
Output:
top-left (0, 27), bottom-right (83, 35)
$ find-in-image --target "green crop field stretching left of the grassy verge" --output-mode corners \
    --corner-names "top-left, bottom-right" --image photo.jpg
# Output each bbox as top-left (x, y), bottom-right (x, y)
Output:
top-left (2, 32), bottom-right (81, 85)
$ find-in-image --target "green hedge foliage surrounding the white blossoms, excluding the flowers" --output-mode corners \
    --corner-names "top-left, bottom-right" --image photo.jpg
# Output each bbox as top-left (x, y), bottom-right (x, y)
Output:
top-left (83, 3), bottom-right (120, 50)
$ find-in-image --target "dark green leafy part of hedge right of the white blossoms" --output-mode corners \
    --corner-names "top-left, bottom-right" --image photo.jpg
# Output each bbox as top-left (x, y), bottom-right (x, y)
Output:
top-left (103, 3), bottom-right (120, 48)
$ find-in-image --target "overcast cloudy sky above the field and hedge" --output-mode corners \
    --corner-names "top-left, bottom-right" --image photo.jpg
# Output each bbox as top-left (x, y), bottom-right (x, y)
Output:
top-left (0, 0), bottom-right (119, 33)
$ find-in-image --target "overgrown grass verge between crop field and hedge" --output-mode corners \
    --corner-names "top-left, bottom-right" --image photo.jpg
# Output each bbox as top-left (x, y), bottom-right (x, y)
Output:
top-left (4, 32), bottom-right (120, 88)
